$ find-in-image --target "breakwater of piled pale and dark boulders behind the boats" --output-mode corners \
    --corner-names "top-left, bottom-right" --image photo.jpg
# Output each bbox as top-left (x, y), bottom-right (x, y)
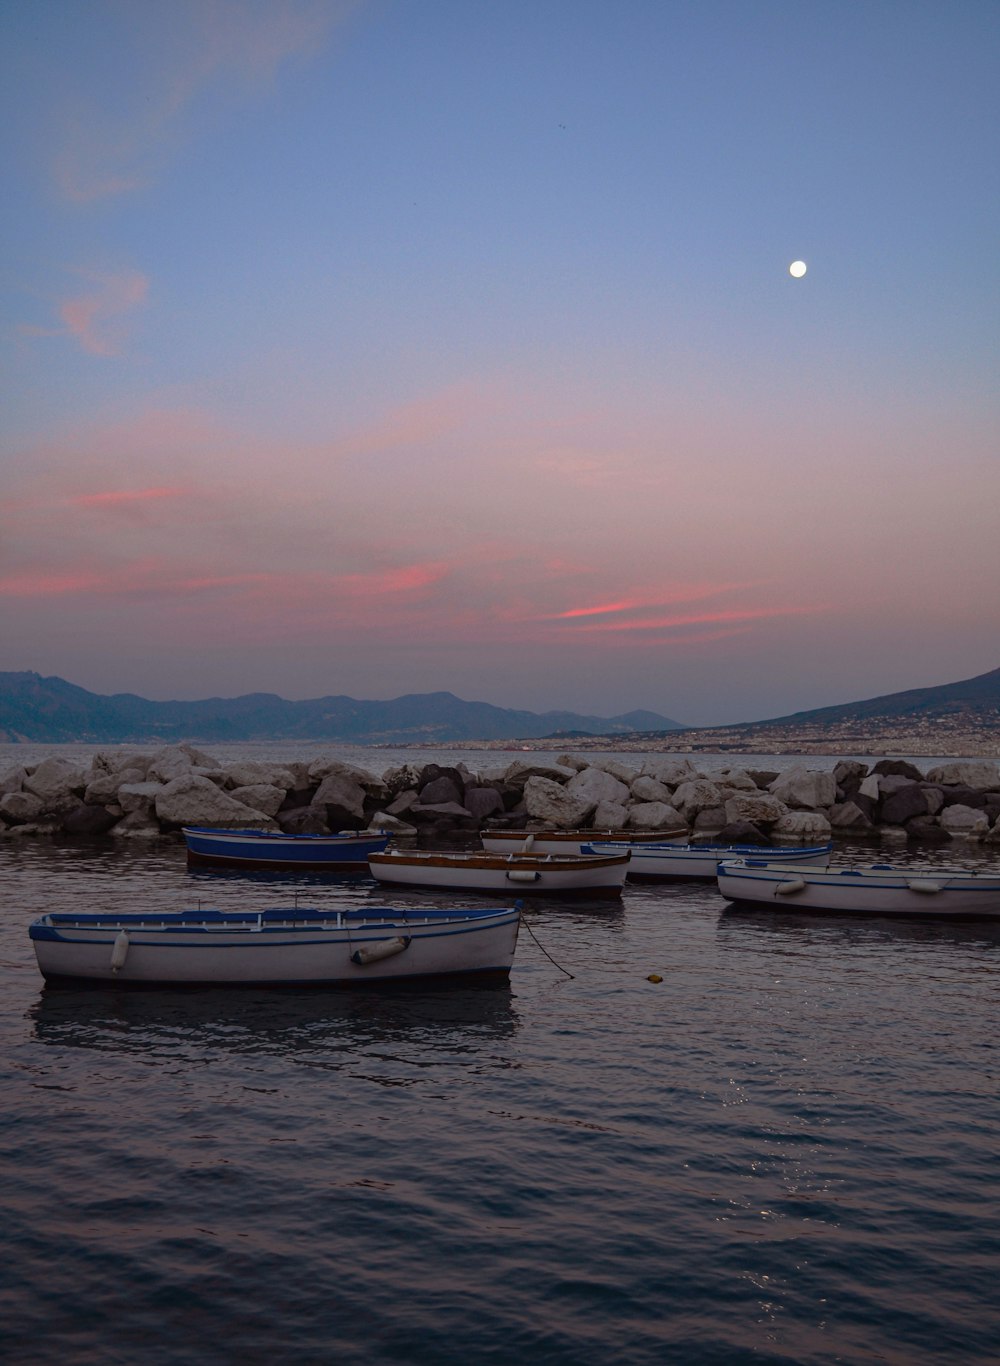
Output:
top-left (0, 744), bottom-right (1000, 844)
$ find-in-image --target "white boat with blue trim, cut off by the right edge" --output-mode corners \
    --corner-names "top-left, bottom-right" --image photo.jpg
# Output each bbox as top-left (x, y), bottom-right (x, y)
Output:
top-left (716, 858), bottom-right (1000, 919)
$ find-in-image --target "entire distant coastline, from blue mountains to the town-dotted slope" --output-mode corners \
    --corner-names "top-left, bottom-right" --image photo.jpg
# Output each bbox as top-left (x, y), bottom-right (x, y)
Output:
top-left (0, 668), bottom-right (1000, 757)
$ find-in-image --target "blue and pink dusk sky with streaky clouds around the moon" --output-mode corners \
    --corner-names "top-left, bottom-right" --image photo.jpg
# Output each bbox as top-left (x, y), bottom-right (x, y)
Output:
top-left (0, 0), bottom-right (1000, 725)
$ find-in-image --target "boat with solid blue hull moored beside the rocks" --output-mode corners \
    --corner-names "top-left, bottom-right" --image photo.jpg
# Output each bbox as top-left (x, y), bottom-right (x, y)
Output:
top-left (182, 825), bottom-right (389, 873)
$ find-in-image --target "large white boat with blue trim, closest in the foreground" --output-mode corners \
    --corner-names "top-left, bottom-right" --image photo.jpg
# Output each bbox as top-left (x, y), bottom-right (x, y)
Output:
top-left (29, 903), bottom-right (520, 986)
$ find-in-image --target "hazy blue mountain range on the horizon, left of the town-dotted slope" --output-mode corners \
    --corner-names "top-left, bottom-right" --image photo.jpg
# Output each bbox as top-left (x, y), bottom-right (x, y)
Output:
top-left (0, 672), bottom-right (682, 744)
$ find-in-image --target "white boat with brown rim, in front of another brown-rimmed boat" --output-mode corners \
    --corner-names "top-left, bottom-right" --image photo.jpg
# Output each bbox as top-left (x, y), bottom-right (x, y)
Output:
top-left (367, 850), bottom-right (628, 896)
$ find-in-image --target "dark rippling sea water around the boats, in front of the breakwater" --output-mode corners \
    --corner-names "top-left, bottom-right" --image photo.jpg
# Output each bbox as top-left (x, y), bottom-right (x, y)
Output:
top-left (0, 754), bottom-right (1000, 1366)
